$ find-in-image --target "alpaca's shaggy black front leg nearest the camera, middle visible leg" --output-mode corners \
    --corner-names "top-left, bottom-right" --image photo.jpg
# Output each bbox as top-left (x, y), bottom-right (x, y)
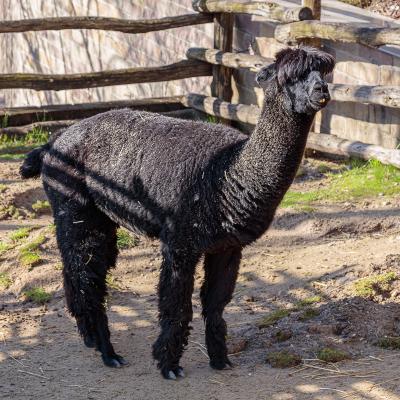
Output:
top-left (153, 246), bottom-right (198, 379)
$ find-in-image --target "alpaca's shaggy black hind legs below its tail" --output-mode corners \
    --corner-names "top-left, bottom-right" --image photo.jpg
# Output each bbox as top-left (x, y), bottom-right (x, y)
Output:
top-left (53, 200), bottom-right (126, 367)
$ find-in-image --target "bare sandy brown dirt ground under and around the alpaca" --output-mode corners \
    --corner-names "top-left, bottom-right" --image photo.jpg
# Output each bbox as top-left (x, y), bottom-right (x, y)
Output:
top-left (0, 157), bottom-right (400, 400)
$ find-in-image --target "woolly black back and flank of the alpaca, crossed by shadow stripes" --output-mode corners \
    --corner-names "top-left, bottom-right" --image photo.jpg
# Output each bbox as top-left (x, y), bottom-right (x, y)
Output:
top-left (47, 109), bottom-right (247, 236)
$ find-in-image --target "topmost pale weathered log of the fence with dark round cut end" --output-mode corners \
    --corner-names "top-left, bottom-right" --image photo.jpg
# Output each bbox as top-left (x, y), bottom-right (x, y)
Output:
top-left (192, 0), bottom-right (312, 22)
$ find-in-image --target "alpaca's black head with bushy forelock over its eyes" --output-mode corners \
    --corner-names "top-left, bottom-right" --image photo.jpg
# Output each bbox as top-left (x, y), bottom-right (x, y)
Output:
top-left (256, 46), bottom-right (335, 114)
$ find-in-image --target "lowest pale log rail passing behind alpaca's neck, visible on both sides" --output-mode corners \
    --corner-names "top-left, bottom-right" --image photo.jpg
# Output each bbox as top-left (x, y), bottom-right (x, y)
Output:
top-left (182, 93), bottom-right (400, 168)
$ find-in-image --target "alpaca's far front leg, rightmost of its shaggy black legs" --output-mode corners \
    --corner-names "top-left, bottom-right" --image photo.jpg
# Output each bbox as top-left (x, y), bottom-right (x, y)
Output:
top-left (200, 249), bottom-right (241, 369)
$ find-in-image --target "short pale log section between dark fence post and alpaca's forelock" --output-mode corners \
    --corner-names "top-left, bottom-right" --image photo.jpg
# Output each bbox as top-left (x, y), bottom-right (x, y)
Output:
top-left (186, 47), bottom-right (273, 71)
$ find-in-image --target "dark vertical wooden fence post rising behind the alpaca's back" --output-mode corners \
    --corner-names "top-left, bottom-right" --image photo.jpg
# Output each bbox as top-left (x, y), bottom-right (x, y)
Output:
top-left (211, 13), bottom-right (234, 124)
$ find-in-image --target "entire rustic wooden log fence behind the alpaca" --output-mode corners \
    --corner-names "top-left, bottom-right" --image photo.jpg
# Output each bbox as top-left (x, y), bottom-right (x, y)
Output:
top-left (0, 0), bottom-right (400, 167)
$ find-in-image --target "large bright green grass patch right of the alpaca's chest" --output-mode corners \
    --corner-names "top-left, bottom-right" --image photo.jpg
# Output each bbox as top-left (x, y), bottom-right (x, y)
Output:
top-left (281, 160), bottom-right (400, 208)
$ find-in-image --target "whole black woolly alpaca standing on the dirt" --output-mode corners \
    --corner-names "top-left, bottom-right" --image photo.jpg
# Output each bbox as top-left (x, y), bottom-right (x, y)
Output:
top-left (21, 47), bottom-right (334, 379)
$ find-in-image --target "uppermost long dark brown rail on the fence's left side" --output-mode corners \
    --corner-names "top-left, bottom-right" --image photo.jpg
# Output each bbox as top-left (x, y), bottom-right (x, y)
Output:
top-left (0, 14), bottom-right (213, 33)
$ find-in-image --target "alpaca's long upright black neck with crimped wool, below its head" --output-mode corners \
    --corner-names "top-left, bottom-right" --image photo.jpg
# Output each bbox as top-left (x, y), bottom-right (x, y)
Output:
top-left (219, 92), bottom-right (314, 243)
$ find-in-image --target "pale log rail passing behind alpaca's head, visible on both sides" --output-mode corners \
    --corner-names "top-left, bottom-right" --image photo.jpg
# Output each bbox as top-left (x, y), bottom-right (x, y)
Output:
top-left (186, 47), bottom-right (400, 108)
